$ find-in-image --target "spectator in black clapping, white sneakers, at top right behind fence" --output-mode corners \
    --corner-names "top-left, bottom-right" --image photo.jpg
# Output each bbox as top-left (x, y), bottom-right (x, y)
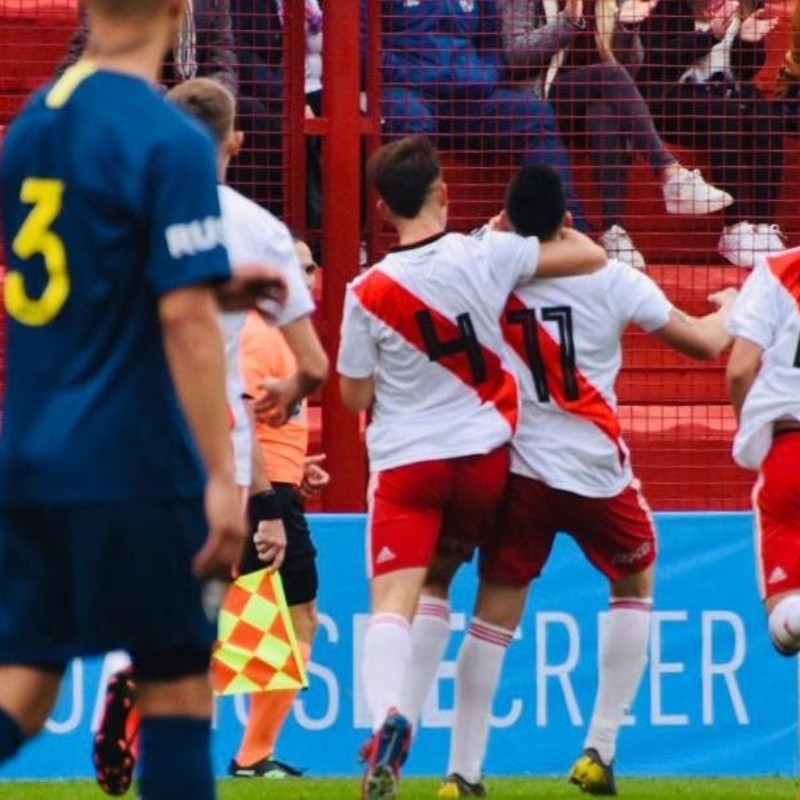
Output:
top-left (636, 0), bottom-right (785, 267)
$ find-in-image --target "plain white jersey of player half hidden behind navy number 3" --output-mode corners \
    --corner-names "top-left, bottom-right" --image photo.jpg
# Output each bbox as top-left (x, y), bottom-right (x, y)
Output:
top-left (219, 186), bottom-right (314, 486)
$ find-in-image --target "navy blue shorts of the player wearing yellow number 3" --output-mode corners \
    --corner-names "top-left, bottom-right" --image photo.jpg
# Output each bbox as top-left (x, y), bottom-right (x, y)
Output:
top-left (0, 498), bottom-right (217, 670)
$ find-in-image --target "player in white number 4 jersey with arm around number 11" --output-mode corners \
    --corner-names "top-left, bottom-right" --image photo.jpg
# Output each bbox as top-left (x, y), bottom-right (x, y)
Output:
top-left (338, 137), bottom-right (605, 800)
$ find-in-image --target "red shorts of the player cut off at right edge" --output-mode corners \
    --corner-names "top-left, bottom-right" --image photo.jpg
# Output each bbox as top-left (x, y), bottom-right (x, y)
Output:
top-left (753, 431), bottom-right (800, 598)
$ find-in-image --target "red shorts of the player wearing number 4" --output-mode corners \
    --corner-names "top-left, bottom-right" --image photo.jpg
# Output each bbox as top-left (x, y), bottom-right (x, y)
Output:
top-left (367, 447), bottom-right (509, 576)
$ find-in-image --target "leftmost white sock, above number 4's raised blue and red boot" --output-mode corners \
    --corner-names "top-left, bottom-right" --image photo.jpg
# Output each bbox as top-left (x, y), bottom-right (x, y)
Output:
top-left (361, 614), bottom-right (411, 730)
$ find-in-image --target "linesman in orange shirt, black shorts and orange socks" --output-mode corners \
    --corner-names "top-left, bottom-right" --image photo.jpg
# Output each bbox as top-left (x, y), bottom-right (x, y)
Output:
top-left (228, 239), bottom-right (330, 779)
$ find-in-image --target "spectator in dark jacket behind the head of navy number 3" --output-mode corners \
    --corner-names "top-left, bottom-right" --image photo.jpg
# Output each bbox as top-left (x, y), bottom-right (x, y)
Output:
top-left (56, 0), bottom-right (238, 96)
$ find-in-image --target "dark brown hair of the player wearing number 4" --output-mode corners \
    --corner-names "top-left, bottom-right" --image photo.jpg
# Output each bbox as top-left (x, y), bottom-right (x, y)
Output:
top-left (367, 136), bottom-right (442, 219)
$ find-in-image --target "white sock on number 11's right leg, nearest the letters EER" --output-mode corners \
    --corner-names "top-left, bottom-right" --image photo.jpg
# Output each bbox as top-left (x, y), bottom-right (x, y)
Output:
top-left (584, 597), bottom-right (653, 764)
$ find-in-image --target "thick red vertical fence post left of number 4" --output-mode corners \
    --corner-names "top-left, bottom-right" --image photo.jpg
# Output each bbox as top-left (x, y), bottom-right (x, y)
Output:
top-left (322, 0), bottom-right (366, 511)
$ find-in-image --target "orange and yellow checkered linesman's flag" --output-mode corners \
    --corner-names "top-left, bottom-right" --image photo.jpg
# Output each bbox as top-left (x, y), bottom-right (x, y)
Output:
top-left (211, 569), bottom-right (308, 694)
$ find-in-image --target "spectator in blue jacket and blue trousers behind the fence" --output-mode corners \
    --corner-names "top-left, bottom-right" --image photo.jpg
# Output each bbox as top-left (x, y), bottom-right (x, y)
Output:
top-left (376, 0), bottom-right (588, 231)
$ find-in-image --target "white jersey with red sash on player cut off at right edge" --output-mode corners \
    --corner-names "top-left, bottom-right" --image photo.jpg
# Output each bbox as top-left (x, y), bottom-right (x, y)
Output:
top-left (728, 248), bottom-right (800, 469)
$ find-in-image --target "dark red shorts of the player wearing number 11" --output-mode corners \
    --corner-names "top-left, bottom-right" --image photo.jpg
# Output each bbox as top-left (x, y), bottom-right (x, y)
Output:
top-left (480, 475), bottom-right (656, 586)
